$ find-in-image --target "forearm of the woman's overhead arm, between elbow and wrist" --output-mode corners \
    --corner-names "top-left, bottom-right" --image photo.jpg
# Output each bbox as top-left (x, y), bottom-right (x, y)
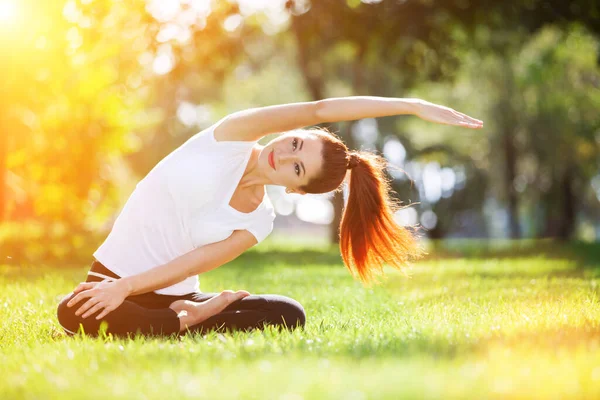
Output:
top-left (317, 96), bottom-right (422, 122)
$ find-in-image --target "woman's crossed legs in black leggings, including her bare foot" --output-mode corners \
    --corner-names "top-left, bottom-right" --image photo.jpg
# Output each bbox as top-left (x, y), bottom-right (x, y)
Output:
top-left (57, 291), bottom-right (306, 337)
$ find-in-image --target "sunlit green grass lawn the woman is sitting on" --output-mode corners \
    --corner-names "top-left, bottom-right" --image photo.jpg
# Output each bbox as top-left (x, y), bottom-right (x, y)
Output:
top-left (0, 242), bottom-right (600, 400)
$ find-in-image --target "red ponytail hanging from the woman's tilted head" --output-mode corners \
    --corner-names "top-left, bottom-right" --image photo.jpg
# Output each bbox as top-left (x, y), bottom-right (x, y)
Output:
top-left (340, 152), bottom-right (425, 283)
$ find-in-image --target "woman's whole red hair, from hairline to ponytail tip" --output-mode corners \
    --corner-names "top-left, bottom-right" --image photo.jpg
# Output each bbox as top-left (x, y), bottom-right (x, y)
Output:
top-left (300, 128), bottom-right (425, 283)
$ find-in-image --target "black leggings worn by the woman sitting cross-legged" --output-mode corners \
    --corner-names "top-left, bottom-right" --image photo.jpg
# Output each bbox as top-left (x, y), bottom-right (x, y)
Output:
top-left (57, 261), bottom-right (306, 337)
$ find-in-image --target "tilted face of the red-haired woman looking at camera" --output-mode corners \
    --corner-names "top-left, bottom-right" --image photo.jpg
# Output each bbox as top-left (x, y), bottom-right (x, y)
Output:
top-left (259, 132), bottom-right (323, 193)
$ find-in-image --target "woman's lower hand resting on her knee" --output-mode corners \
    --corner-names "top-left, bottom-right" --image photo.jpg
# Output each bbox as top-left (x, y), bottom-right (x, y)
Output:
top-left (67, 279), bottom-right (129, 319)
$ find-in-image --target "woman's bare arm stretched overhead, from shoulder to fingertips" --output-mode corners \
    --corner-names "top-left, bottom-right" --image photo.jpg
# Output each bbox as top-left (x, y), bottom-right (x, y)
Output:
top-left (215, 96), bottom-right (483, 141)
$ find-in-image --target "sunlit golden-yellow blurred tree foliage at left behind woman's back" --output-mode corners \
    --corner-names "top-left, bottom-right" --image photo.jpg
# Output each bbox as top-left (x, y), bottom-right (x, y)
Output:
top-left (0, 0), bottom-right (268, 225)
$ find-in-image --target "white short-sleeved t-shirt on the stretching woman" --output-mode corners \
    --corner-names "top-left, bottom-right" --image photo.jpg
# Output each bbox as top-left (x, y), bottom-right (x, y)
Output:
top-left (94, 120), bottom-right (275, 295)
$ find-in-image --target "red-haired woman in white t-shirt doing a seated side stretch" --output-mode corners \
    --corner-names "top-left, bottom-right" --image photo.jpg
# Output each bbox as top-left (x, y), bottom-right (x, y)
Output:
top-left (58, 96), bottom-right (483, 336)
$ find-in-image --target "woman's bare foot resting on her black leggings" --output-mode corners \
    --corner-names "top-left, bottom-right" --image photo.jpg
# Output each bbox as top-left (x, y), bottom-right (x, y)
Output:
top-left (169, 290), bottom-right (250, 332)
